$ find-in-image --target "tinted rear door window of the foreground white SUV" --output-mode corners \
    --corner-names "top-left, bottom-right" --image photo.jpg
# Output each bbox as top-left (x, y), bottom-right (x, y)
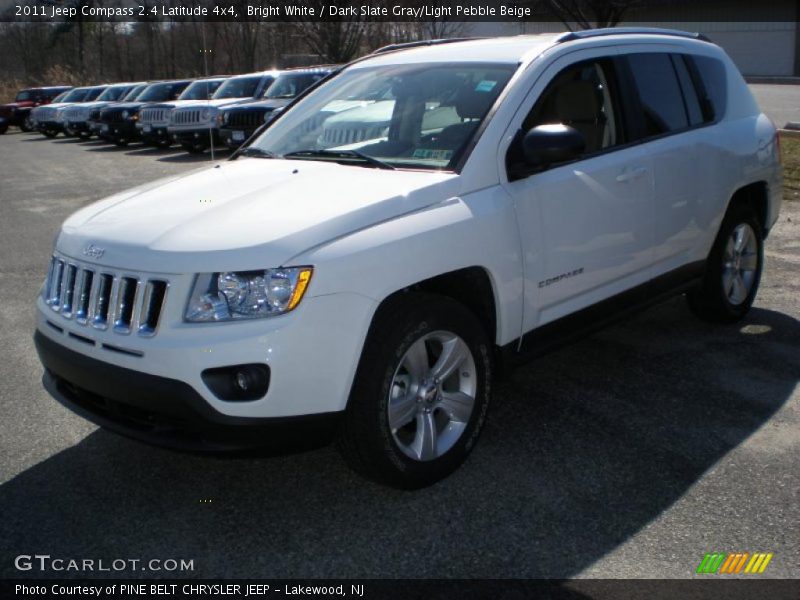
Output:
top-left (627, 53), bottom-right (689, 137)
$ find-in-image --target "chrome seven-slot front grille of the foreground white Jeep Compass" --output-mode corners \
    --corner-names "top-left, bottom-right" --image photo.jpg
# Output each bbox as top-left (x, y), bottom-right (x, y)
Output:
top-left (44, 256), bottom-right (168, 337)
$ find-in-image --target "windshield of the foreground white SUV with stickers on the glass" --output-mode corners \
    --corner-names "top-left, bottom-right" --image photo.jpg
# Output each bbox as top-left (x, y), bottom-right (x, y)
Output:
top-left (251, 63), bottom-right (516, 169)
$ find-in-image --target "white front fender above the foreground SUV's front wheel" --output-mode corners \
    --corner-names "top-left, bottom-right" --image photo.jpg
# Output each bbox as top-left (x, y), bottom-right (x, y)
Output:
top-left (291, 186), bottom-right (523, 344)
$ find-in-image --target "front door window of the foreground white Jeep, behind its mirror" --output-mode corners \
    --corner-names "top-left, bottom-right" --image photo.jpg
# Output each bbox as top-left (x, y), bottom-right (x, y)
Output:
top-left (522, 60), bottom-right (622, 154)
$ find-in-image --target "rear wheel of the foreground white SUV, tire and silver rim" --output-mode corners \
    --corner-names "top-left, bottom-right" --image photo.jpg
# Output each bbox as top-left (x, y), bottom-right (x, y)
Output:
top-left (686, 206), bottom-right (764, 323)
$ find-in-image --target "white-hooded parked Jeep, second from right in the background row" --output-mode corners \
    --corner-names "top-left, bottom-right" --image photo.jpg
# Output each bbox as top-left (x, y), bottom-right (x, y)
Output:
top-left (167, 71), bottom-right (280, 154)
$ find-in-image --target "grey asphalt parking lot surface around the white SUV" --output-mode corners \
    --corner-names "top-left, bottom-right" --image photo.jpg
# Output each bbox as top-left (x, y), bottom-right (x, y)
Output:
top-left (0, 104), bottom-right (800, 578)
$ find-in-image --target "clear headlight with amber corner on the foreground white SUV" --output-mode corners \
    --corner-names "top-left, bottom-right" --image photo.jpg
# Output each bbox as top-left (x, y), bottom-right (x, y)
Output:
top-left (184, 267), bottom-right (314, 322)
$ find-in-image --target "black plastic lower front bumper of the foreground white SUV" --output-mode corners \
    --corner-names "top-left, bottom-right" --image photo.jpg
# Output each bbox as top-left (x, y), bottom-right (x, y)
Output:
top-left (34, 331), bottom-right (341, 451)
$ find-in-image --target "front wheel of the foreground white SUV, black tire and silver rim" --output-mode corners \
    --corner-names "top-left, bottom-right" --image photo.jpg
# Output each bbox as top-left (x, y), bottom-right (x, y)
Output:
top-left (337, 293), bottom-right (491, 489)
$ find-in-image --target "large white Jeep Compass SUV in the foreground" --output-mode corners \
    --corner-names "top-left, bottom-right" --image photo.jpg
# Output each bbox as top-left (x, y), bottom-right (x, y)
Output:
top-left (35, 29), bottom-right (781, 488)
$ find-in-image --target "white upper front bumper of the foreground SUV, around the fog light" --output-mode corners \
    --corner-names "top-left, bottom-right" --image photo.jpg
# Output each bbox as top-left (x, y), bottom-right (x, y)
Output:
top-left (37, 288), bottom-right (375, 419)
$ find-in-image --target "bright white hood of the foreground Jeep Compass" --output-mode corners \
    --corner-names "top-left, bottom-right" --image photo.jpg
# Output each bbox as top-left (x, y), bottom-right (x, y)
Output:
top-left (56, 157), bottom-right (459, 273)
